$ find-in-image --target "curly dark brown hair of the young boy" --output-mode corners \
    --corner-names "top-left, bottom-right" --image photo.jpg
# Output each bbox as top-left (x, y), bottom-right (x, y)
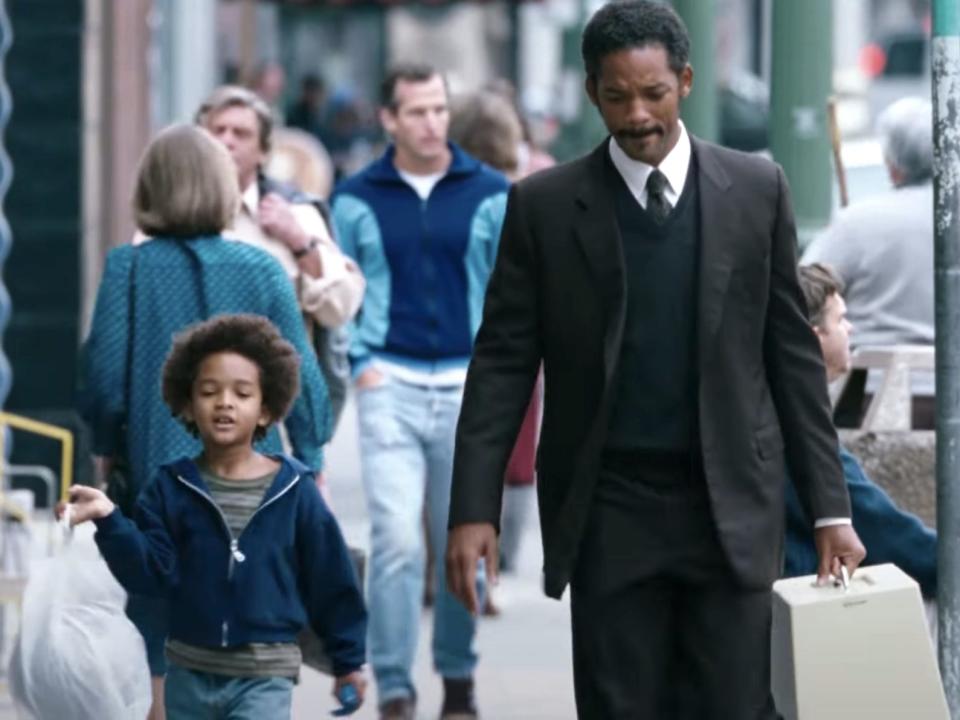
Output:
top-left (163, 314), bottom-right (300, 440)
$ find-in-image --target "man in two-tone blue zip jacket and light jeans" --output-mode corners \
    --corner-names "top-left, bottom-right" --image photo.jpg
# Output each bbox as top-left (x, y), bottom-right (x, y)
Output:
top-left (333, 65), bottom-right (507, 720)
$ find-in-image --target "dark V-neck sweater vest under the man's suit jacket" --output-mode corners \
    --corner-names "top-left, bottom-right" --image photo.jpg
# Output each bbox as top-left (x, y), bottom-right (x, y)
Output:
top-left (606, 157), bottom-right (700, 452)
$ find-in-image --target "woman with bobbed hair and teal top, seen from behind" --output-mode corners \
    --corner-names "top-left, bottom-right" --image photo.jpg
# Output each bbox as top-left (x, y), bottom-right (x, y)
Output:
top-left (80, 125), bottom-right (330, 720)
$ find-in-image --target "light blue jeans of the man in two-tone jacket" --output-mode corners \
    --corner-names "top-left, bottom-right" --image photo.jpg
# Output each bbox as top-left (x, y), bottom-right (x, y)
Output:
top-left (357, 375), bottom-right (482, 703)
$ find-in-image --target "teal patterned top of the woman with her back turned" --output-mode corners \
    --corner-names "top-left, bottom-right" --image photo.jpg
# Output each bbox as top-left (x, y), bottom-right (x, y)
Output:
top-left (79, 237), bottom-right (330, 490)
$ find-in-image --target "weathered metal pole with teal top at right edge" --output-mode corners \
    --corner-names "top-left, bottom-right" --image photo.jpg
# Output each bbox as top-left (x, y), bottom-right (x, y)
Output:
top-left (931, 0), bottom-right (960, 718)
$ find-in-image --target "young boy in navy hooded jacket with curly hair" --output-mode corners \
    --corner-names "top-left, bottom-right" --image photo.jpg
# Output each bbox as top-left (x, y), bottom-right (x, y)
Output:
top-left (60, 315), bottom-right (366, 720)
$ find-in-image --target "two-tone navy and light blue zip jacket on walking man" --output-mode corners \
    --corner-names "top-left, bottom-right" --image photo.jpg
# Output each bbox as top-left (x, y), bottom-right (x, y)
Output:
top-left (333, 143), bottom-right (508, 376)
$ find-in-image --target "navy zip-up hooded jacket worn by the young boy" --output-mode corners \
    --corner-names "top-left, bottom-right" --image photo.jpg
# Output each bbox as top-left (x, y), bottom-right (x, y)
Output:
top-left (94, 455), bottom-right (367, 676)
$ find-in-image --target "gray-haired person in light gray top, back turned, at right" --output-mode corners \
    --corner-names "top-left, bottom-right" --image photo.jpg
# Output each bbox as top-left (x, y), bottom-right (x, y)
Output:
top-left (802, 98), bottom-right (934, 347)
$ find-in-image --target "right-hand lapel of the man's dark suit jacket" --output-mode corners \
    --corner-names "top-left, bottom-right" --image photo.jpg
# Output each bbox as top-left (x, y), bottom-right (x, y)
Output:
top-left (690, 141), bottom-right (737, 350)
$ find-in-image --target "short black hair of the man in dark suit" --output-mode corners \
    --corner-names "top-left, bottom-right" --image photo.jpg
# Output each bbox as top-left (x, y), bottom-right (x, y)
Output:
top-left (580, 0), bottom-right (690, 79)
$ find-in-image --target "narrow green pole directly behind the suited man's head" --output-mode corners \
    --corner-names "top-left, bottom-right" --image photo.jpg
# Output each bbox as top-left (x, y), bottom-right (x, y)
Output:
top-left (673, 0), bottom-right (720, 142)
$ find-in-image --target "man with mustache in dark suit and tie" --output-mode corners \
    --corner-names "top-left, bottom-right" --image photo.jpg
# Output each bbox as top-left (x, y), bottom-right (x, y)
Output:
top-left (447, 0), bottom-right (864, 720)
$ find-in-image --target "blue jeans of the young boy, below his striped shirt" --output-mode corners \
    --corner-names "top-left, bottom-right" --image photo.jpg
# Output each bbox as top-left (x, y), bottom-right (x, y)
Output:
top-left (163, 665), bottom-right (293, 720)
